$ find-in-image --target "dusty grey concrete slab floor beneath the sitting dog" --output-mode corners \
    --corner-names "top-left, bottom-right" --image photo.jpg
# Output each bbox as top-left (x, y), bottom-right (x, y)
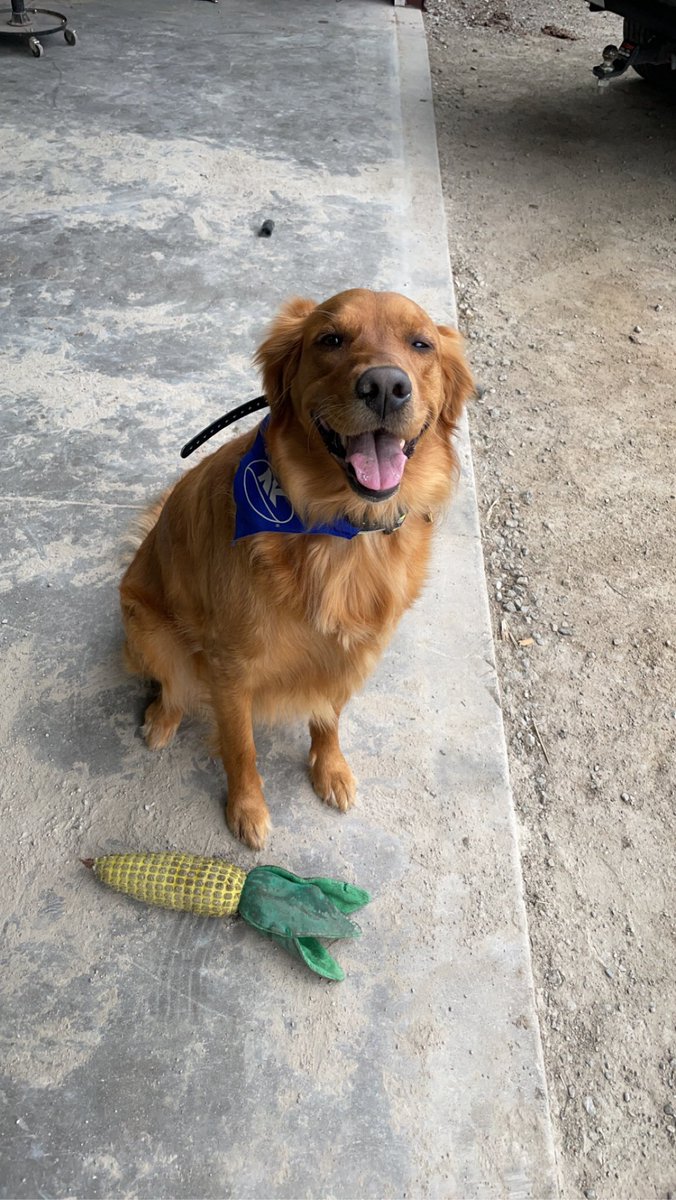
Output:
top-left (0, 0), bottom-right (556, 1200)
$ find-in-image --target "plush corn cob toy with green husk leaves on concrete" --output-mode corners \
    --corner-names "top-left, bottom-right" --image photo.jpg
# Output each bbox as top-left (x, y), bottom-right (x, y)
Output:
top-left (82, 852), bottom-right (371, 979)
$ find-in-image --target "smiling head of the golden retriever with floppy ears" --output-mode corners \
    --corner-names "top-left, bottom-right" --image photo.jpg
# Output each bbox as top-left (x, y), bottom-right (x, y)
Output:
top-left (257, 289), bottom-right (473, 520)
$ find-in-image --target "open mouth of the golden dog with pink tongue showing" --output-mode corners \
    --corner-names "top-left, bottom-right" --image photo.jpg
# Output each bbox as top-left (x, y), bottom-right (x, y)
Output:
top-left (315, 418), bottom-right (418, 500)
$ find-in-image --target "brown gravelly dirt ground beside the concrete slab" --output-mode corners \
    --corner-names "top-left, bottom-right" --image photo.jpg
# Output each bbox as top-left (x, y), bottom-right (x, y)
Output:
top-left (425, 0), bottom-right (676, 1200)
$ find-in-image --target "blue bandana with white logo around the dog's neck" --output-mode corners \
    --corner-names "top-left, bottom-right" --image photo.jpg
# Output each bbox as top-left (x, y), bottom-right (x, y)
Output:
top-left (233, 416), bottom-right (361, 541)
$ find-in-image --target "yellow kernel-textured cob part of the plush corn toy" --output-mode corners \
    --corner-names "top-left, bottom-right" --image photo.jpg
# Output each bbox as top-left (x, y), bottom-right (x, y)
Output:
top-left (92, 852), bottom-right (246, 917)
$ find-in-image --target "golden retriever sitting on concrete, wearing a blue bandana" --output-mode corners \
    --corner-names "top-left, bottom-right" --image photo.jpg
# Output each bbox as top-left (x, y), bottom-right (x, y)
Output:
top-left (121, 289), bottom-right (473, 850)
